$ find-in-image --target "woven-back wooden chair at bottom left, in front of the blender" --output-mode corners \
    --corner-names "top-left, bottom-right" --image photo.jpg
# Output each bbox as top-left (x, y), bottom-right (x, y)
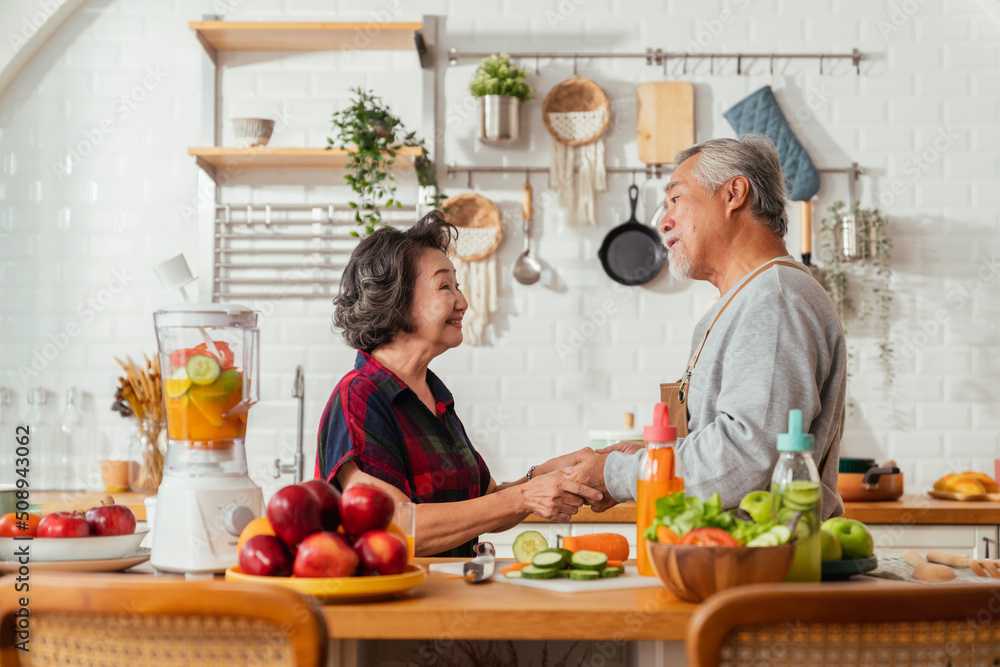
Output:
top-left (0, 574), bottom-right (328, 667)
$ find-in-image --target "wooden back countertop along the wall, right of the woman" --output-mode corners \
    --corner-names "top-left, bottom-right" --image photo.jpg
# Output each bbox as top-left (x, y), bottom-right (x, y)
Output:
top-left (525, 495), bottom-right (1000, 525)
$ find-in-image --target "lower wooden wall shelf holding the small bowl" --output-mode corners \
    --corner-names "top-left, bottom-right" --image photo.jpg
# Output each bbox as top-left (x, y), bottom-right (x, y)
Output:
top-left (188, 146), bottom-right (421, 182)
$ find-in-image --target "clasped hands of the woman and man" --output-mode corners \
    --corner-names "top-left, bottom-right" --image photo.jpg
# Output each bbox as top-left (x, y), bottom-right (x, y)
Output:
top-left (521, 442), bottom-right (642, 522)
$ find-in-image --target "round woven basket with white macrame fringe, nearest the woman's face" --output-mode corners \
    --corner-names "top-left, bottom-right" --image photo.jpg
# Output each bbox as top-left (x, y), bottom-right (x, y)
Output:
top-left (441, 193), bottom-right (503, 345)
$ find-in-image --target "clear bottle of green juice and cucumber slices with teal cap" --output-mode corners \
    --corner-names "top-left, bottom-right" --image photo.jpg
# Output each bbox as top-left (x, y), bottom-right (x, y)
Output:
top-left (771, 410), bottom-right (822, 582)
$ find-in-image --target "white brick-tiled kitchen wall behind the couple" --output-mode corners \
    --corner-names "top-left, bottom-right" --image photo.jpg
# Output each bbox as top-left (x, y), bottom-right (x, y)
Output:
top-left (0, 0), bottom-right (1000, 500)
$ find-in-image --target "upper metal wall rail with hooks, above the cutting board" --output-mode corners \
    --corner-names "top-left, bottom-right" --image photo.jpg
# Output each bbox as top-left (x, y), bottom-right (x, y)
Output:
top-left (448, 49), bottom-right (865, 76)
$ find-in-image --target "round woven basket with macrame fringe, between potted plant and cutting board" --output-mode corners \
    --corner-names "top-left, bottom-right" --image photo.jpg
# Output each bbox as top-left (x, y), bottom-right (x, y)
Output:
top-left (542, 76), bottom-right (611, 225)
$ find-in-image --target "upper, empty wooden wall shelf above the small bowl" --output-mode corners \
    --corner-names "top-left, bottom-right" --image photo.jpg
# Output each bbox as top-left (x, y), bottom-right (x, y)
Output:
top-left (188, 21), bottom-right (423, 51)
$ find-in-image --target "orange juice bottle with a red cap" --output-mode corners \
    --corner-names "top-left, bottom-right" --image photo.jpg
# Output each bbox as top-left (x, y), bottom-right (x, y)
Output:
top-left (635, 403), bottom-right (684, 577)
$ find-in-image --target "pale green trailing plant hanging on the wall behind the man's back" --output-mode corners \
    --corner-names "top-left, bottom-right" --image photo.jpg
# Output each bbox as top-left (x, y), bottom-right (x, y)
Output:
top-left (819, 201), bottom-right (895, 387)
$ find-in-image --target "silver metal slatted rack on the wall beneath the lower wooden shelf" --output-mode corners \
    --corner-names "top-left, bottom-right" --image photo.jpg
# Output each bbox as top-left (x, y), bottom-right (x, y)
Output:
top-left (213, 204), bottom-right (417, 301)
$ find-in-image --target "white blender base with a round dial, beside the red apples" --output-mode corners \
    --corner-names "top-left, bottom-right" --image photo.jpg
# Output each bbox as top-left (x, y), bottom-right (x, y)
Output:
top-left (149, 475), bottom-right (264, 574)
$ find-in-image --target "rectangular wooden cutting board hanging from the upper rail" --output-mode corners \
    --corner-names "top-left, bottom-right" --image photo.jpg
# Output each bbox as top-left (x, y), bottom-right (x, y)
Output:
top-left (636, 81), bottom-right (694, 164)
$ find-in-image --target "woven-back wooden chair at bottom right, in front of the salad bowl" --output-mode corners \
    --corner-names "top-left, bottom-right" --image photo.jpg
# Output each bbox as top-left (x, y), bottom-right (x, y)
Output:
top-left (687, 582), bottom-right (1000, 667)
